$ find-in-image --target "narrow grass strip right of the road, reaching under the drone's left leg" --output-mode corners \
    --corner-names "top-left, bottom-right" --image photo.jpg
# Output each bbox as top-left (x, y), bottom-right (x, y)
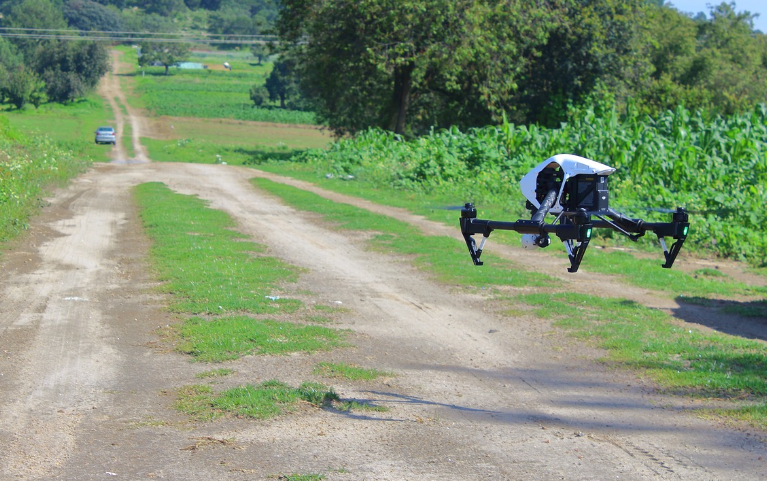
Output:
top-left (252, 179), bottom-right (554, 287)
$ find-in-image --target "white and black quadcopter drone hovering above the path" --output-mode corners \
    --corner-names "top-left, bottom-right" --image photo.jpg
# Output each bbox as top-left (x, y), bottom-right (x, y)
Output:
top-left (460, 154), bottom-right (690, 272)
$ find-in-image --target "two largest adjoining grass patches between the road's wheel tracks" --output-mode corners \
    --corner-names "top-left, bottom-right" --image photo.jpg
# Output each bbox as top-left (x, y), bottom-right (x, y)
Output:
top-left (136, 183), bottom-right (344, 362)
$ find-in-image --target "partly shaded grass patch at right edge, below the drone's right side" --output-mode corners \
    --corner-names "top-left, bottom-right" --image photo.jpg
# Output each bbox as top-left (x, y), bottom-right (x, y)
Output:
top-left (516, 293), bottom-right (767, 401)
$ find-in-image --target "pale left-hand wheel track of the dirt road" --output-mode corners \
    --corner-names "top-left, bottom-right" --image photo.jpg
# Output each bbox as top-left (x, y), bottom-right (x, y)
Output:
top-left (0, 172), bottom-right (127, 478)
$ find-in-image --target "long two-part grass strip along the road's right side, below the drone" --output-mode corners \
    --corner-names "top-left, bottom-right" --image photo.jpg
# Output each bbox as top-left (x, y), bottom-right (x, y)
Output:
top-left (253, 179), bottom-right (767, 429)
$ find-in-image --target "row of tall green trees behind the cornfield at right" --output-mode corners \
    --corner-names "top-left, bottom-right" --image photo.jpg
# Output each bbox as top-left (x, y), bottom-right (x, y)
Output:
top-left (278, 0), bottom-right (767, 135)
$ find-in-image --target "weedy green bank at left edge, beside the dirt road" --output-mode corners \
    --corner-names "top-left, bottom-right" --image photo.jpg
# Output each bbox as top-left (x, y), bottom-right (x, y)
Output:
top-left (0, 117), bottom-right (91, 244)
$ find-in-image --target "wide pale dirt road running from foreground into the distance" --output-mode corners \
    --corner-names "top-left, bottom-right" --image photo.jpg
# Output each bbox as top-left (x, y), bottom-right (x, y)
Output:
top-left (0, 58), bottom-right (767, 480)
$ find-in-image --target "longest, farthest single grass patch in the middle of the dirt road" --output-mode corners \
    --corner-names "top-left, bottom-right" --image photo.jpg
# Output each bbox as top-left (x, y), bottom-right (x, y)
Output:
top-left (135, 183), bottom-right (301, 315)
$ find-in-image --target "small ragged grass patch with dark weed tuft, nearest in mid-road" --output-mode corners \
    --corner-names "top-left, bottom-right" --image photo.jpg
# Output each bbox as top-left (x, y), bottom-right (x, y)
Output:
top-left (175, 380), bottom-right (338, 421)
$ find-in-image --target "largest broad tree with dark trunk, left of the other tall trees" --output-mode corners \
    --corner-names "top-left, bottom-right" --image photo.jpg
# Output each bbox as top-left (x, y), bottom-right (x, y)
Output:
top-left (278, 0), bottom-right (550, 134)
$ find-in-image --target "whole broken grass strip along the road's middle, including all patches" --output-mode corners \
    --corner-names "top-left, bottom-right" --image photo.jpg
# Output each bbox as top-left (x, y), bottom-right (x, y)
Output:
top-left (134, 183), bottom-right (389, 420)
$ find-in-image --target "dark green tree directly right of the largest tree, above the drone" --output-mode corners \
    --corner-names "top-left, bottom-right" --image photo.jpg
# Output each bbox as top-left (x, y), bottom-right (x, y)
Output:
top-left (510, 0), bottom-right (651, 127)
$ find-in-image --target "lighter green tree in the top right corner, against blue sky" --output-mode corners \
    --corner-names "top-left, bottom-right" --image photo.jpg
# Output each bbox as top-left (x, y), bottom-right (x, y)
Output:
top-left (636, 3), bottom-right (767, 114)
